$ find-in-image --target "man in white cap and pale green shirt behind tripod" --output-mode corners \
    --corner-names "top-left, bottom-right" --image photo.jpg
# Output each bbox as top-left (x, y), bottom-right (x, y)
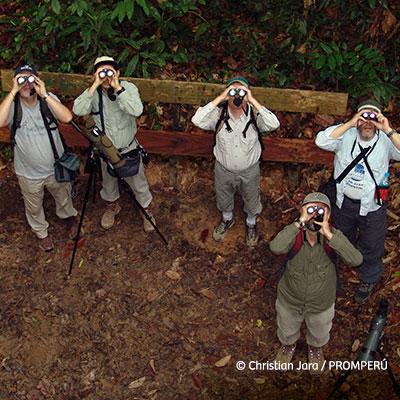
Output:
top-left (72, 56), bottom-right (155, 232)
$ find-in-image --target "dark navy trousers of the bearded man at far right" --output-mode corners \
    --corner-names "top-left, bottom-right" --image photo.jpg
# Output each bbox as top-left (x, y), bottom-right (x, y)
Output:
top-left (332, 197), bottom-right (387, 283)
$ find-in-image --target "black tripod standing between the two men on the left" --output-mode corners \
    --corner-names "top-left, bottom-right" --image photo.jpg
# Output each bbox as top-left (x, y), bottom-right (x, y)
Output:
top-left (67, 120), bottom-right (168, 279)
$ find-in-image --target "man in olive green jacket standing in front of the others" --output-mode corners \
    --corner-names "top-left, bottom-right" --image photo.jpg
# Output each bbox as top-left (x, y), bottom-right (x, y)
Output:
top-left (270, 192), bottom-right (362, 375)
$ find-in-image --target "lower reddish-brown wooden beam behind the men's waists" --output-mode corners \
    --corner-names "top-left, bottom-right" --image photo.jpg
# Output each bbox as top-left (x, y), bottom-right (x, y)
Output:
top-left (0, 124), bottom-right (333, 164)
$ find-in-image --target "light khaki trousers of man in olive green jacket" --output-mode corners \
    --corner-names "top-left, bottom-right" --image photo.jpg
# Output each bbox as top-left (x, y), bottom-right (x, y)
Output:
top-left (275, 299), bottom-right (335, 347)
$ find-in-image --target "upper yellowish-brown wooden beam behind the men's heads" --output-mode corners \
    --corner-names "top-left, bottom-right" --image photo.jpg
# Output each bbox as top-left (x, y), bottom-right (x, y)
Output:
top-left (1, 69), bottom-right (348, 115)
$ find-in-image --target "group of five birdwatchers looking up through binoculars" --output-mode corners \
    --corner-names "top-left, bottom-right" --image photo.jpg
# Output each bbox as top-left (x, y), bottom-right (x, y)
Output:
top-left (0, 56), bottom-right (400, 375)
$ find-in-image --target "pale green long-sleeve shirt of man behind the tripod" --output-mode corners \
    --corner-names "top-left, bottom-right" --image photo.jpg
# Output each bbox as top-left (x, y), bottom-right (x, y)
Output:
top-left (72, 81), bottom-right (143, 149)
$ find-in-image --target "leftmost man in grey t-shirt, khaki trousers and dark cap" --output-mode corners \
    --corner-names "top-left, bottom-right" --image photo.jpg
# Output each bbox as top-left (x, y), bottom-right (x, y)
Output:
top-left (0, 64), bottom-right (78, 252)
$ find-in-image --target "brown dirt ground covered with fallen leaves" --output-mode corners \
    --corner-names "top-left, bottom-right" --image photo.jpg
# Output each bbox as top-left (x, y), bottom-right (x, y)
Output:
top-left (0, 157), bottom-right (400, 400)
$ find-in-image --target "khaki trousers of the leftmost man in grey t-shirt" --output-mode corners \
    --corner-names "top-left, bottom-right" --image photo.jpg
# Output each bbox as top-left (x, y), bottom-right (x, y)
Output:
top-left (17, 175), bottom-right (78, 239)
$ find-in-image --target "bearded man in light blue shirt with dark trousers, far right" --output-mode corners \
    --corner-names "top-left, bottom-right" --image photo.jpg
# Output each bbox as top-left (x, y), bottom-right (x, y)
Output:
top-left (315, 99), bottom-right (400, 303)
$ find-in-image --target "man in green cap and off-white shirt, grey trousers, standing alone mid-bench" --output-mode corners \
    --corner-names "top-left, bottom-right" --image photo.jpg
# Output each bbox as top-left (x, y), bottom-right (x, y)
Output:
top-left (192, 76), bottom-right (279, 247)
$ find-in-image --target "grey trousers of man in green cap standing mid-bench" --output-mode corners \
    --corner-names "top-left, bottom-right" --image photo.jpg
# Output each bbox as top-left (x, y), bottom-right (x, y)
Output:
top-left (214, 161), bottom-right (262, 216)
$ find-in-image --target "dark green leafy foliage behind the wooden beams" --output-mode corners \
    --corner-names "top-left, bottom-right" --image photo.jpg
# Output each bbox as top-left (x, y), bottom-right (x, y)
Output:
top-left (0, 0), bottom-right (400, 103)
